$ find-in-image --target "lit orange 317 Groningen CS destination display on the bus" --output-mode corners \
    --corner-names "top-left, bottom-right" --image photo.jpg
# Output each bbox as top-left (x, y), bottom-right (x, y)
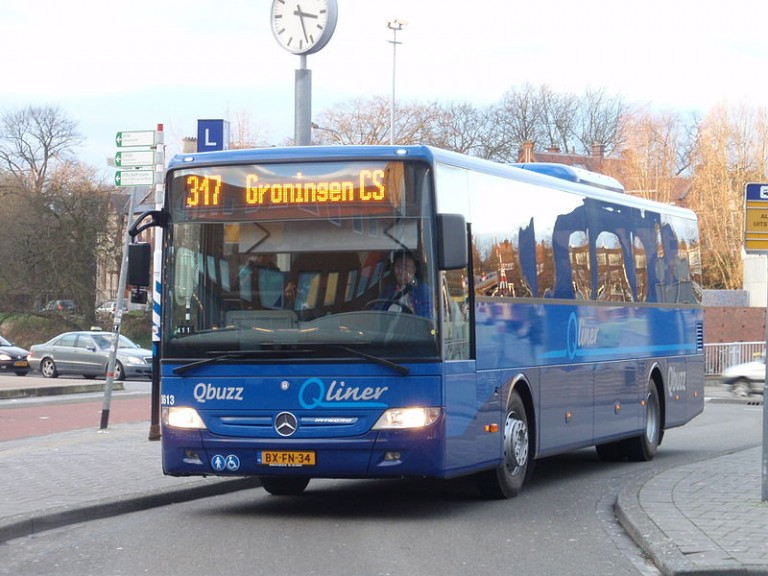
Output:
top-left (171, 163), bottom-right (403, 217)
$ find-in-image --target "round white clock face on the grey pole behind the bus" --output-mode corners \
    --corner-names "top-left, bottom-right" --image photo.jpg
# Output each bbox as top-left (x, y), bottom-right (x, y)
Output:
top-left (272, 0), bottom-right (337, 54)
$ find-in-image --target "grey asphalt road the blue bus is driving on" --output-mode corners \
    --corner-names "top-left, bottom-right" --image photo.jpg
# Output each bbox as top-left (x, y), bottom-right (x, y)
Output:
top-left (3, 396), bottom-right (762, 576)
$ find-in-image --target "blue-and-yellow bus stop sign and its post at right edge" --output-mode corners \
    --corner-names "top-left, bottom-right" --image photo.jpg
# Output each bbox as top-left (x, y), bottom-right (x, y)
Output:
top-left (744, 182), bottom-right (768, 502)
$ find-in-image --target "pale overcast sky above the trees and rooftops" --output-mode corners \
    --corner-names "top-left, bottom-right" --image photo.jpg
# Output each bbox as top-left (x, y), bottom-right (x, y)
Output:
top-left (0, 0), bottom-right (768, 172)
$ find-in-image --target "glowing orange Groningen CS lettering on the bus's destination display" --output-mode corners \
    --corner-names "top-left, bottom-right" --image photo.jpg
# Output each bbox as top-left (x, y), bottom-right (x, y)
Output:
top-left (245, 170), bottom-right (386, 206)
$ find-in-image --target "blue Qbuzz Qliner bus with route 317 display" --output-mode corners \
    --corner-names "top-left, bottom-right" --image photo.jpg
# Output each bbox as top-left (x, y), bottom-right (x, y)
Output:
top-left (129, 146), bottom-right (704, 498)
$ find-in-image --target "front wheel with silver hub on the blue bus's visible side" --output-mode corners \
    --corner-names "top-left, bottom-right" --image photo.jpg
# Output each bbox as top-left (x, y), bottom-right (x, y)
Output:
top-left (477, 392), bottom-right (533, 500)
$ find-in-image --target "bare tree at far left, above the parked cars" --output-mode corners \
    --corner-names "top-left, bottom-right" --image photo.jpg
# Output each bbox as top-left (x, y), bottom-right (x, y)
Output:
top-left (0, 107), bottom-right (107, 314)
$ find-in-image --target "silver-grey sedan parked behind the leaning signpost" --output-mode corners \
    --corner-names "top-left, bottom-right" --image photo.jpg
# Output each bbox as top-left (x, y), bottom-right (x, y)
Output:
top-left (28, 330), bottom-right (152, 380)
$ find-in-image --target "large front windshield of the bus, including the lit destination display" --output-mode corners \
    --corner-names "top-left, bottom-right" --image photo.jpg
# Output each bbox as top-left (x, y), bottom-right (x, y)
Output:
top-left (162, 161), bottom-right (438, 360)
